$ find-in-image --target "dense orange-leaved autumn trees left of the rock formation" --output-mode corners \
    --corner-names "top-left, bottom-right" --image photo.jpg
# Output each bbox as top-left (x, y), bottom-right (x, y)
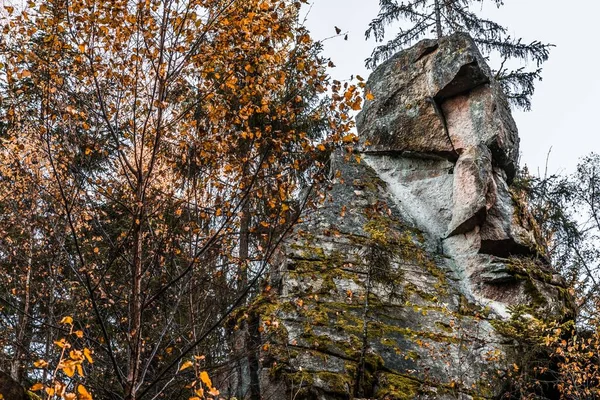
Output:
top-left (0, 0), bottom-right (361, 400)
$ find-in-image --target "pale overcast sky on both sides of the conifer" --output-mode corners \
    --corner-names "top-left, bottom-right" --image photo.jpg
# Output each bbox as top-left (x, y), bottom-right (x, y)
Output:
top-left (306, 0), bottom-right (600, 177)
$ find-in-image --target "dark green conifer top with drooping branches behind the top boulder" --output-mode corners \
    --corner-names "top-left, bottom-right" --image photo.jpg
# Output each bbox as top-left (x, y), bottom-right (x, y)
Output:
top-left (365, 0), bottom-right (552, 111)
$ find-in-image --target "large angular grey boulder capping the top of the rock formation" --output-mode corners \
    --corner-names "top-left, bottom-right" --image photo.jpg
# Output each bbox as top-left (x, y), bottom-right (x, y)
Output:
top-left (357, 34), bottom-right (519, 180)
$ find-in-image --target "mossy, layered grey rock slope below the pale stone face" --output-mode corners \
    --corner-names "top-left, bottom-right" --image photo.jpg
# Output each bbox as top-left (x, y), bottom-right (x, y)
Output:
top-left (253, 156), bottom-right (510, 399)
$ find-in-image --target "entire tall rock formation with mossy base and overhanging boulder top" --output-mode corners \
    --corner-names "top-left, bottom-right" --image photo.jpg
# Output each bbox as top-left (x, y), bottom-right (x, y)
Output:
top-left (255, 34), bottom-right (570, 400)
